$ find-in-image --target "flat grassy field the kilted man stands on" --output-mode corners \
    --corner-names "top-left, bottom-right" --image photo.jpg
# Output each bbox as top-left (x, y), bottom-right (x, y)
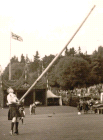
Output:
top-left (0, 106), bottom-right (103, 140)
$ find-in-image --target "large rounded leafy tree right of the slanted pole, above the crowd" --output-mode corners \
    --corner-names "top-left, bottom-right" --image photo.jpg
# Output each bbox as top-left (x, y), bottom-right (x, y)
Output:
top-left (55, 56), bottom-right (89, 89)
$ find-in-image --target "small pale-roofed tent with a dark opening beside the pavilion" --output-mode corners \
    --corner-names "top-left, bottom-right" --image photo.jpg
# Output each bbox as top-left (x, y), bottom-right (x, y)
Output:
top-left (47, 90), bottom-right (62, 105)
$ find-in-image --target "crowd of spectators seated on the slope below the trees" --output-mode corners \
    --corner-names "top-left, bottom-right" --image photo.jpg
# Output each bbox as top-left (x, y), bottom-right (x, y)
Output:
top-left (50, 84), bottom-right (103, 104)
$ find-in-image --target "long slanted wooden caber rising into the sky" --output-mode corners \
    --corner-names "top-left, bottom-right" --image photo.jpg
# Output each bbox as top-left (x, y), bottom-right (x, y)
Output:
top-left (20, 5), bottom-right (95, 101)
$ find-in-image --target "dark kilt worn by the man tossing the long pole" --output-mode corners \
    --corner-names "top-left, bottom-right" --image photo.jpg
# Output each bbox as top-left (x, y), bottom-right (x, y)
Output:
top-left (8, 104), bottom-right (21, 120)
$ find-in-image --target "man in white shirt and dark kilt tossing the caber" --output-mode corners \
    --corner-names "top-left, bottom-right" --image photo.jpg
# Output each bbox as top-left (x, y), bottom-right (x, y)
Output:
top-left (7, 87), bottom-right (20, 135)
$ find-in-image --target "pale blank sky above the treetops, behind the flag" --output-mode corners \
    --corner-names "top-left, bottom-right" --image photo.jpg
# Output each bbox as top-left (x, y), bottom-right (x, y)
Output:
top-left (0, 0), bottom-right (103, 70)
